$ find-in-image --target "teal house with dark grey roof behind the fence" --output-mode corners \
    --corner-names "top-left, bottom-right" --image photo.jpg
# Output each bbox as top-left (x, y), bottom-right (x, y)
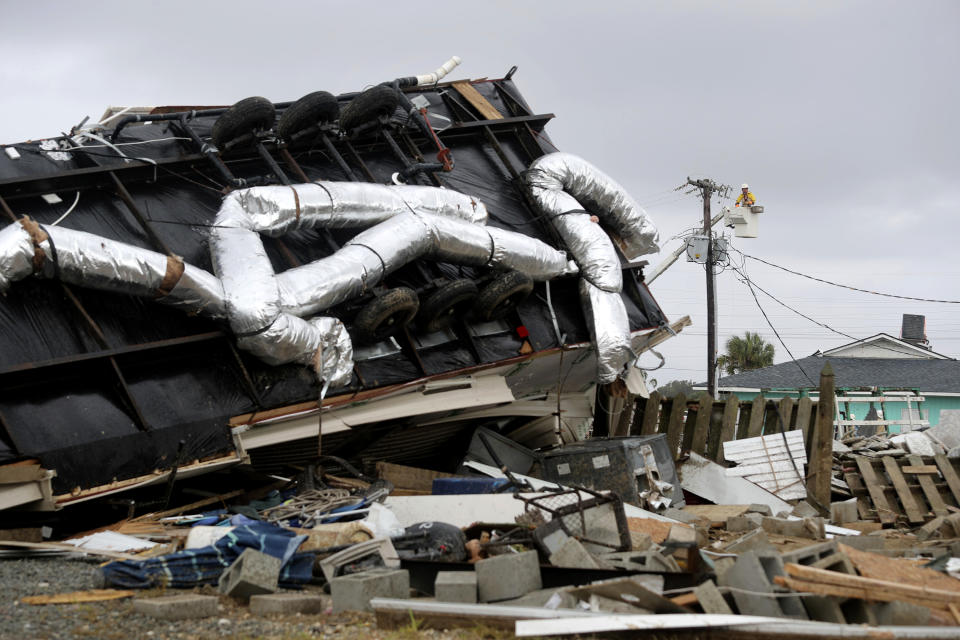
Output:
top-left (704, 316), bottom-right (960, 433)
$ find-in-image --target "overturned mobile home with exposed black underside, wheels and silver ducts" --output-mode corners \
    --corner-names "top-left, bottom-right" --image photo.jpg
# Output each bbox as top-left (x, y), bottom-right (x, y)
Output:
top-left (0, 58), bottom-right (685, 509)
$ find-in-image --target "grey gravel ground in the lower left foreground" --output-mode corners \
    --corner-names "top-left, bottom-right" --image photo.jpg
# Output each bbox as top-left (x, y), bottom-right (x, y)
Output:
top-left (0, 556), bottom-right (513, 640)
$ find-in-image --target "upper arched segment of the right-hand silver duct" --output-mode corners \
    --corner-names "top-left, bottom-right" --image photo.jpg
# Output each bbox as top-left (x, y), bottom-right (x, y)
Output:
top-left (524, 153), bottom-right (660, 258)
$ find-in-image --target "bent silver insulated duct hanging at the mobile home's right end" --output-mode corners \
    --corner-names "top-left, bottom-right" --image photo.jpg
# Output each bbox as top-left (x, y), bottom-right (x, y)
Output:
top-left (523, 153), bottom-right (659, 384)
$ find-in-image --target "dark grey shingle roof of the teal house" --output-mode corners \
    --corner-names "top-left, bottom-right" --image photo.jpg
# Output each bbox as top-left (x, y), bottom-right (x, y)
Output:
top-left (719, 355), bottom-right (960, 393)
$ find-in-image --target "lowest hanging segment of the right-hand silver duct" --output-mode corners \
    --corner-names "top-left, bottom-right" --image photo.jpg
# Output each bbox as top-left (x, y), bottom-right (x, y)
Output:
top-left (580, 280), bottom-right (634, 384)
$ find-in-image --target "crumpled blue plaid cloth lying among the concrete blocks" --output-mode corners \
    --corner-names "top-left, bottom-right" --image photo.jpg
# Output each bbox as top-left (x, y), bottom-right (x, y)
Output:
top-left (101, 522), bottom-right (314, 589)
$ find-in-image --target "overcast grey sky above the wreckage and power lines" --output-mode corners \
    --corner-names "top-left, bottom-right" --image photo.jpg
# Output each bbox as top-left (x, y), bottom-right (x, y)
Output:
top-left (0, 0), bottom-right (960, 384)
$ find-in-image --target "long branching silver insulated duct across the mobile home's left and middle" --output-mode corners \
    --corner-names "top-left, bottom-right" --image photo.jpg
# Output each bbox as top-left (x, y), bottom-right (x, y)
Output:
top-left (0, 182), bottom-right (577, 387)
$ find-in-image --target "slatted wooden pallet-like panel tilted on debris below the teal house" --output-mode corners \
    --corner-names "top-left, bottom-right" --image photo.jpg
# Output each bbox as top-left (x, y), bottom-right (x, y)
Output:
top-left (843, 455), bottom-right (960, 526)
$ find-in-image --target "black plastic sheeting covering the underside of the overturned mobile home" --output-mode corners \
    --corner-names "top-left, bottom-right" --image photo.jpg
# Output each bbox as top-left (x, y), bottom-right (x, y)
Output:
top-left (0, 81), bottom-right (665, 493)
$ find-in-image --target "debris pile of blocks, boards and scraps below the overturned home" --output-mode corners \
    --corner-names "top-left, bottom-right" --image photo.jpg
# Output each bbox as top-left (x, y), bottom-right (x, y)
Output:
top-left (0, 422), bottom-right (960, 637)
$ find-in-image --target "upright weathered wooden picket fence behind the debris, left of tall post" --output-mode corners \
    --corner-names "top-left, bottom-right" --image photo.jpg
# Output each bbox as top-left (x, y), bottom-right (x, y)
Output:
top-left (624, 391), bottom-right (817, 462)
